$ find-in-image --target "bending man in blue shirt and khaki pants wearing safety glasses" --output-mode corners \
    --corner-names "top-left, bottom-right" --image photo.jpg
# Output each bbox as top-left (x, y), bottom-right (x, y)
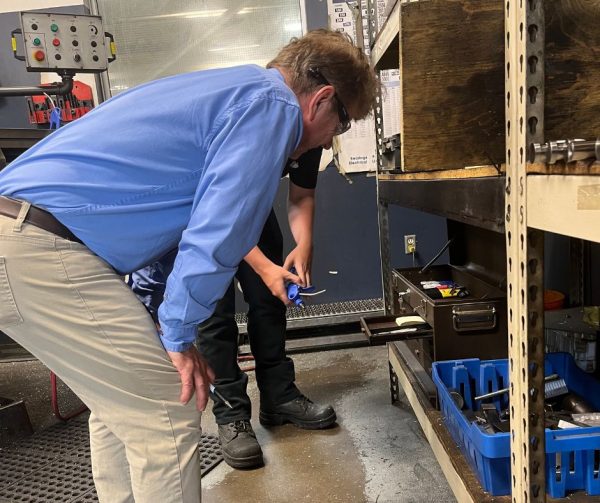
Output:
top-left (0, 30), bottom-right (377, 503)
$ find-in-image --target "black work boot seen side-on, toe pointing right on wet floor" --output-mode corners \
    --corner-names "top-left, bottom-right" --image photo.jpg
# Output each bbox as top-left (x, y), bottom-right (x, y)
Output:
top-left (259, 395), bottom-right (336, 430)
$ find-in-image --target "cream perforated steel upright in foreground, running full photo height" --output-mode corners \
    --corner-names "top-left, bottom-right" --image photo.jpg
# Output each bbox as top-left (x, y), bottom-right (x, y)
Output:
top-left (504, 0), bottom-right (546, 503)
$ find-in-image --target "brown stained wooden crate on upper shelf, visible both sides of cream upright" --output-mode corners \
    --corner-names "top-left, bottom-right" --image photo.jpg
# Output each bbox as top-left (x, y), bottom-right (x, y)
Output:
top-left (400, 0), bottom-right (600, 173)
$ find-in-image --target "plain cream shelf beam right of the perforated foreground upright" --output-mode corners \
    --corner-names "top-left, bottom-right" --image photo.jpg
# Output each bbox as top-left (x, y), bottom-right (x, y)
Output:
top-left (527, 175), bottom-right (600, 243)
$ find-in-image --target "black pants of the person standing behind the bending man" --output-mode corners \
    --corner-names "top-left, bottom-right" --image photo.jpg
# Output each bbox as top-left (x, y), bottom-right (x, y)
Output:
top-left (197, 210), bottom-right (300, 424)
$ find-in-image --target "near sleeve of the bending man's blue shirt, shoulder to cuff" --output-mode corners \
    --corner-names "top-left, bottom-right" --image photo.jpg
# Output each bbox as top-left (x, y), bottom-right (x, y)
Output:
top-left (159, 98), bottom-right (302, 351)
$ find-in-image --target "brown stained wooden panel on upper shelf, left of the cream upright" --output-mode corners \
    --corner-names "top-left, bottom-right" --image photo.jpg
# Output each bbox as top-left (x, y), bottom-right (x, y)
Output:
top-left (400, 0), bottom-right (504, 171)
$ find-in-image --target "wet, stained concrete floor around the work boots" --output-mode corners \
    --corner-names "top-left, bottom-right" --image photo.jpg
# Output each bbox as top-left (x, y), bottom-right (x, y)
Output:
top-left (0, 346), bottom-right (456, 503)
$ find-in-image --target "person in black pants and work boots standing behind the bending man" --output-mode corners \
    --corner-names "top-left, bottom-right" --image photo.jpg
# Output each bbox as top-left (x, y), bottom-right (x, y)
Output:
top-left (129, 148), bottom-right (336, 468)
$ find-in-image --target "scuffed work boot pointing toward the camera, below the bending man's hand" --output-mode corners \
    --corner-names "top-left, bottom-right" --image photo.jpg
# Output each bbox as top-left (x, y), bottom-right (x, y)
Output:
top-left (219, 419), bottom-right (263, 468)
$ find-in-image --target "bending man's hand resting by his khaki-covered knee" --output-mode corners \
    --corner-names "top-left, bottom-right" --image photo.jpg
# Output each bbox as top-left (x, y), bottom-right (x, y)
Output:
top-left (167, 346), bottom-right (215, 412)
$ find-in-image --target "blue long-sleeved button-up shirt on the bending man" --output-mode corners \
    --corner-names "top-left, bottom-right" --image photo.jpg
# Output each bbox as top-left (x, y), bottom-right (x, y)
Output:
top-left (0, 65), bottom-right (302, 351)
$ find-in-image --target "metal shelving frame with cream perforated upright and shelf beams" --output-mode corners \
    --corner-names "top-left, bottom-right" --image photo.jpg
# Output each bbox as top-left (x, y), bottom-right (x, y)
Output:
top-left (372, 0), bottom-right (600, 503)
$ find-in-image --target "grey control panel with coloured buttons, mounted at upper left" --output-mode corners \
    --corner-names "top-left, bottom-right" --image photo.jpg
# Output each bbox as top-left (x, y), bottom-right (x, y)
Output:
top-left (19, 12), bottom-right (114, 73)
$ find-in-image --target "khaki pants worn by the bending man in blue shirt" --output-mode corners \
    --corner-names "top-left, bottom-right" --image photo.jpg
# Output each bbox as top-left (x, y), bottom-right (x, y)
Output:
top-left (0, 204), bottom-right (201, 503)
